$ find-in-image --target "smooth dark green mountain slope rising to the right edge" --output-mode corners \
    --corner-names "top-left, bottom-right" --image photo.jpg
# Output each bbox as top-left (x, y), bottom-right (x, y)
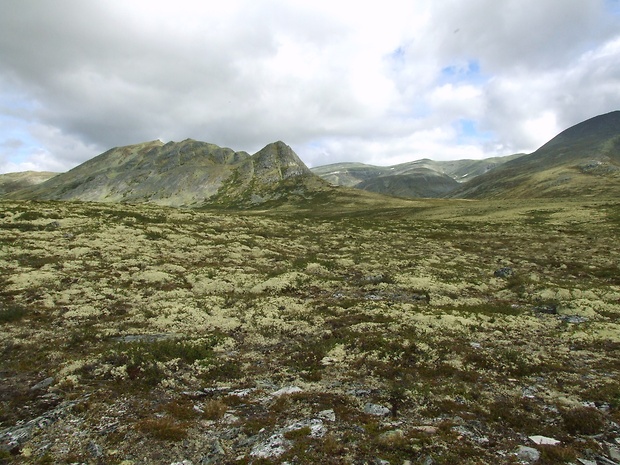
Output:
top-left (450, 111), bottom-right (620, 199)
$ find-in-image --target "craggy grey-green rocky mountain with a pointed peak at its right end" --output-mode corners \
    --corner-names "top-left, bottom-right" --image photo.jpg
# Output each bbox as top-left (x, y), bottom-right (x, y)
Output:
top-left (7, 139), bottom-right (327, 207)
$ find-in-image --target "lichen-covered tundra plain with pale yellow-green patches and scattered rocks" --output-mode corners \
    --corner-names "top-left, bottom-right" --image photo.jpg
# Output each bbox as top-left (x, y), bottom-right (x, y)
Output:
top-left (0, 197), bottom-right (620, 464)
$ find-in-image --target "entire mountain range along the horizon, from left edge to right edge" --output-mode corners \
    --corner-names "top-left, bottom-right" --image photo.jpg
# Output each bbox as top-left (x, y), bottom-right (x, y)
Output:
top-left (0, 111), bottom-right (620, 208)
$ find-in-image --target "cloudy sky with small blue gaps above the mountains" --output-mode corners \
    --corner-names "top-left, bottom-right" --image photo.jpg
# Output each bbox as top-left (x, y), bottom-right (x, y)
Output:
top-left (0, 0), bottom-right (620, 173)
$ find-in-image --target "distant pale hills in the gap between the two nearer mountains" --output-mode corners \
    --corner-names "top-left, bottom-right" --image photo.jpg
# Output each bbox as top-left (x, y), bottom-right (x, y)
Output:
top-left (312, 154), bottom-right (522, 198)
